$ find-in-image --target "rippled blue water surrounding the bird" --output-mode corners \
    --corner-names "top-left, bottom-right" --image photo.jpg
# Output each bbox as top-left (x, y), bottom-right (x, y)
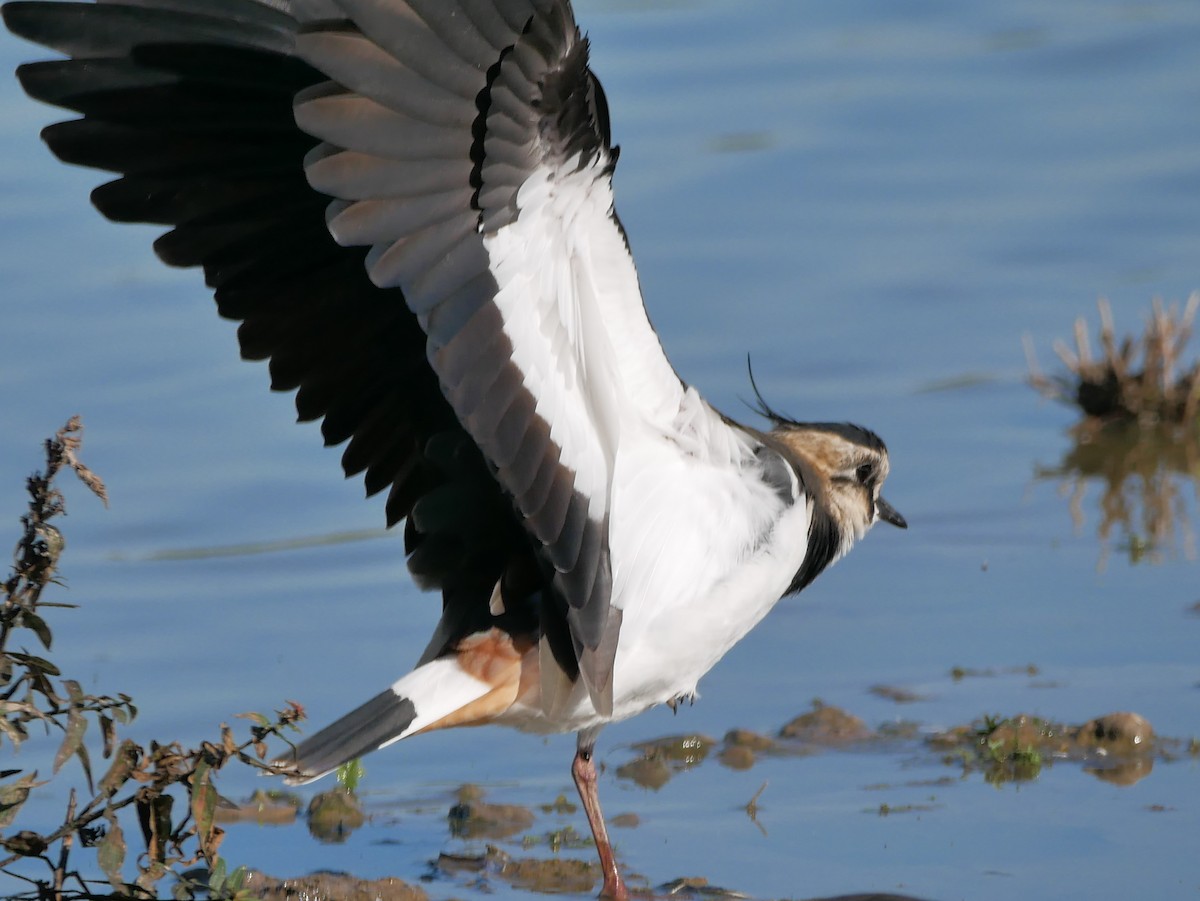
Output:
top-left (0, 0), bottom-right (1200, 899)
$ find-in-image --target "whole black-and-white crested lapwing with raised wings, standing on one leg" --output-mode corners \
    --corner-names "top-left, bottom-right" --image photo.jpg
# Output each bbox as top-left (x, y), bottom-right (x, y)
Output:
top-left (2, 0), bottom-right (906, 901)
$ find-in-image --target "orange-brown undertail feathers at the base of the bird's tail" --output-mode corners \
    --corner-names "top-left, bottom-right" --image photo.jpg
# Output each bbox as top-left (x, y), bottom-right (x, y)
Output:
top-left (413, 629), bottom-right (539, 735)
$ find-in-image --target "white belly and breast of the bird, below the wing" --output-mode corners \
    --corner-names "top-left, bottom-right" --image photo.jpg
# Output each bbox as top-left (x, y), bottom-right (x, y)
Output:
top-left (492, 434), bottom-right (809, 732)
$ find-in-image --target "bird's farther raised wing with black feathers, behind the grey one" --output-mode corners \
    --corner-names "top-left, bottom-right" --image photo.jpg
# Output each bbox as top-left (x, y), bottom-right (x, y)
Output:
top-left (4, 0), bottom-right (535, 656)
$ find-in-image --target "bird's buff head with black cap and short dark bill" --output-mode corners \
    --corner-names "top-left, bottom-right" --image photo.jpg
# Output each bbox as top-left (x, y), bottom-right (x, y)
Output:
top-left (772, 420), bottom-right (908, 541)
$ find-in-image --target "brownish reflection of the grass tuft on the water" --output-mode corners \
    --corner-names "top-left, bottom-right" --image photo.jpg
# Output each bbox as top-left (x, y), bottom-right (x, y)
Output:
top-left (1034, 421), bottom-right (1200, 567)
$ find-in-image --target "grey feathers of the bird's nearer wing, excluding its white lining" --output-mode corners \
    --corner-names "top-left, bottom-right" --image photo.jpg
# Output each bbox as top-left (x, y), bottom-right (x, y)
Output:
top-left (296, 0), bottom-right (619, 711)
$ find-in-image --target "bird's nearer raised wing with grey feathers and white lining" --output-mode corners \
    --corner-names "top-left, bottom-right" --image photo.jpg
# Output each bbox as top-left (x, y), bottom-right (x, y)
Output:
top-left (296, 0), bottom-right (683, 710)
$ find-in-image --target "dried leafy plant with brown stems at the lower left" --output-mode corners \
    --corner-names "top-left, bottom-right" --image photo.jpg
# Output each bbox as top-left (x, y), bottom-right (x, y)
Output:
top-left (0, 418), bottom-right (304, 901)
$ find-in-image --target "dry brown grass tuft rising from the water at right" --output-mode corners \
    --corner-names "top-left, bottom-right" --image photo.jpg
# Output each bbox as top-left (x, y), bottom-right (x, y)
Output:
top-left (1025, 292), bottom-right (1200, 426)
